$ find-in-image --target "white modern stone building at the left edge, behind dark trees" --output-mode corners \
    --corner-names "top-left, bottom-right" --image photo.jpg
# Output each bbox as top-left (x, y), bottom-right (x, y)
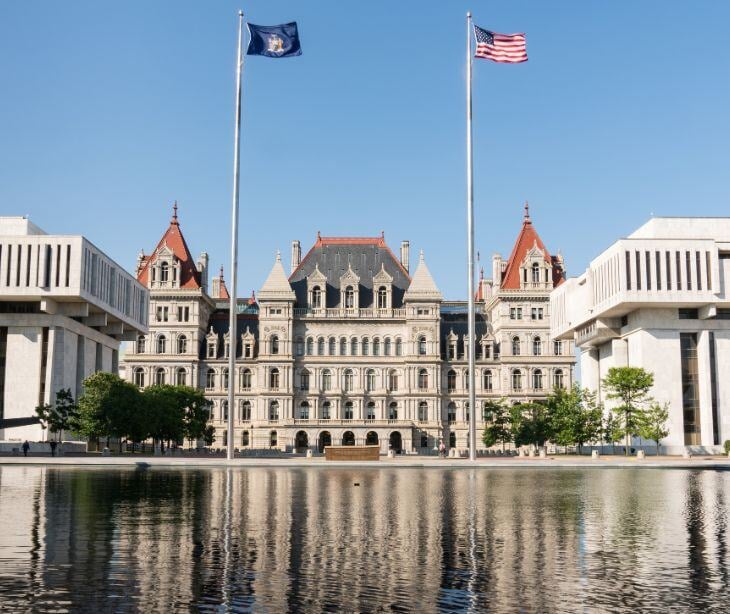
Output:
top-left (0, 217), bottom-right (149, 441)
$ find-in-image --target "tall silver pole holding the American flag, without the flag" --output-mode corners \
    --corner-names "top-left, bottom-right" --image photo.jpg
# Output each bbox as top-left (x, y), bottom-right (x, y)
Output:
top-left (466, 12), bottom-right (477, 461)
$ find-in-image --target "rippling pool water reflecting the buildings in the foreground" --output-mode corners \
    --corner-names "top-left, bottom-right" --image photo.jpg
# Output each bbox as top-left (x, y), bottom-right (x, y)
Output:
top-left (0, 467), bottom-right (730, 612)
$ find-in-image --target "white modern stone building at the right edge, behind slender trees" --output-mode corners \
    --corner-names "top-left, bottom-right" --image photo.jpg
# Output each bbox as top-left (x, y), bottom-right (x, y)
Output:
top-left (550, 217), bottom-right (730, 453)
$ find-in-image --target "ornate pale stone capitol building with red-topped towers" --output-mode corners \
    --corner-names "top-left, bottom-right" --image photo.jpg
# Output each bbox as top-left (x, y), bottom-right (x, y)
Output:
top-left (120, 206), bottom-right (575, 454)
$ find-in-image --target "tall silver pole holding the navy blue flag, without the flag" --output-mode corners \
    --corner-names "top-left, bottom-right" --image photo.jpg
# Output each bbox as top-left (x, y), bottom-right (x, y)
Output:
top-left (226, 11), bottom-right (243, 460)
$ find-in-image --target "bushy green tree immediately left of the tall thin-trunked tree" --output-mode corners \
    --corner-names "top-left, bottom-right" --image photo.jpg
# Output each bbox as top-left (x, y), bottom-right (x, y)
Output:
top-left (547, 385), bottom-right (601, 451)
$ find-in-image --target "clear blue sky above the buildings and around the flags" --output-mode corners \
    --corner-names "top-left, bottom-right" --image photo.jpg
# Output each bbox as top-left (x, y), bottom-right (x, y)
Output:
top-left (0, 0), bottom-right (730, 298)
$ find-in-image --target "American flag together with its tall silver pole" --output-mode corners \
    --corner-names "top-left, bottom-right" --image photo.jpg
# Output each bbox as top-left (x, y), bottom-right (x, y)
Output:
top-left (466, 13), bottom-right (527, 461)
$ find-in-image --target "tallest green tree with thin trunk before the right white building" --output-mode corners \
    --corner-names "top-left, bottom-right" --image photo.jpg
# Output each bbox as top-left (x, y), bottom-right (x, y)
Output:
top-left (603, 367), bottom-right (654, 455)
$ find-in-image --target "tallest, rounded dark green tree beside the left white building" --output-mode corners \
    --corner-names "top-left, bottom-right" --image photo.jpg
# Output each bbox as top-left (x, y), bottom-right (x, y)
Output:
top-left (76, 371), bottom-right (142, 446)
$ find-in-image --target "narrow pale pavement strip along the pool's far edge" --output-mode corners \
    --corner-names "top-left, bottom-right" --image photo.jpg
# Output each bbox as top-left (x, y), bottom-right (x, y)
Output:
top-left (0, 454), bottom-right (730, 470)
